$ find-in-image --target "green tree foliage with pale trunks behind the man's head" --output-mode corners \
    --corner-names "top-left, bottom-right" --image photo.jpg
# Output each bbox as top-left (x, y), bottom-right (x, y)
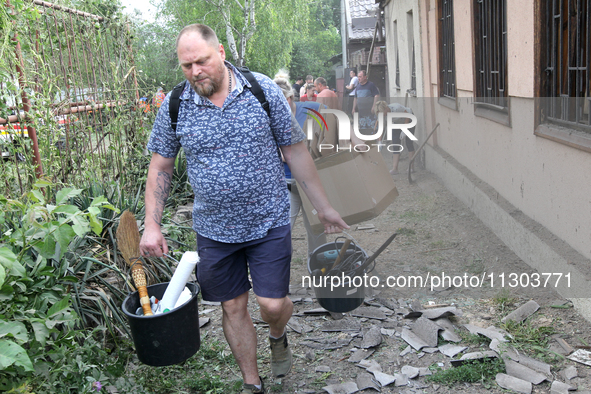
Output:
top-left (136, 0), bottom-right (340, 90)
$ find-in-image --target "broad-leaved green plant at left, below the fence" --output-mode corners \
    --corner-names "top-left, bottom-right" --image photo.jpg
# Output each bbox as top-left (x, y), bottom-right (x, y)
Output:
top-left (0, 182), bottom-right (133, 392)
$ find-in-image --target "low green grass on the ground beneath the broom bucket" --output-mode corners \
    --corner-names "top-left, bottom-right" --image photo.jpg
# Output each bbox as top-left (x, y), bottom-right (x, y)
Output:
top-left (134, 341), bottom-right (242, 394)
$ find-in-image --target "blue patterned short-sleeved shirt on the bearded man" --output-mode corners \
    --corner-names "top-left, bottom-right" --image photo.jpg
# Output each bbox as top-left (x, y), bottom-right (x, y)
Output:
top-left (148, 62), bottom-right (306, 243)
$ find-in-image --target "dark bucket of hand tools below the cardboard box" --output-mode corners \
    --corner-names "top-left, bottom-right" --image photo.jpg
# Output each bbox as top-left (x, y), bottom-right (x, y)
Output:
top-left (308, 241), bottom-right (367, 313)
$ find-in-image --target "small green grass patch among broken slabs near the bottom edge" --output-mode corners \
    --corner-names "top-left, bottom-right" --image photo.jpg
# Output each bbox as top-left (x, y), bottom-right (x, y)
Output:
top-left (425, 358), bottom-right (505, 387)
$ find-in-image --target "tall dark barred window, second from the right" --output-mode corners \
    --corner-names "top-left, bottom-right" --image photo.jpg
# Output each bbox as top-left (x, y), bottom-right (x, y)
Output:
top-left (474, 0), bottom-right (508, 112)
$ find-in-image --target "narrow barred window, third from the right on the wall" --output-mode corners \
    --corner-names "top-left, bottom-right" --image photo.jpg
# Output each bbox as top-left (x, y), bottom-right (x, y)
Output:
top-left (438, 0), bottom-right (456, 99)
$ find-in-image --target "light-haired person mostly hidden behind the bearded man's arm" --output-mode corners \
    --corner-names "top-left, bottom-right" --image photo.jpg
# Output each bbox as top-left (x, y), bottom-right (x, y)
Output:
top-left (274, 70), bottom-right (326, 256)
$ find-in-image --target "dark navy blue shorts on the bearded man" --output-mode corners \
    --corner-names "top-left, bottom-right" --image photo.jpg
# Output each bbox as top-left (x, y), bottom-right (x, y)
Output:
top-left (196, 224), bottom-right (292, 302)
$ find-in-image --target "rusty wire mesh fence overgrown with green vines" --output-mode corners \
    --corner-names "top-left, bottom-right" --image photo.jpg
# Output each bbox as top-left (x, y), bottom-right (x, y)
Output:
top-left (0, 0), bottom-right (153, 195)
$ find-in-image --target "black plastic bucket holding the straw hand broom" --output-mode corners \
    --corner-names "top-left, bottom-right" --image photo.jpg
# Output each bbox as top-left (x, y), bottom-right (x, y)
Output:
top-left (123, 282), bottom-right (201, 367)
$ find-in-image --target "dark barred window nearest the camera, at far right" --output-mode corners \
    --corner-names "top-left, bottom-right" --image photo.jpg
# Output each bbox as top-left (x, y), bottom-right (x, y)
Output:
top-left (542, 0), bottom-right (591, 132)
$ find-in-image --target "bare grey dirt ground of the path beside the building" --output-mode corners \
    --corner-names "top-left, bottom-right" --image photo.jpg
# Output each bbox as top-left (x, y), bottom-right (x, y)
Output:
top-left (201, 155), bottom-right (591, 394)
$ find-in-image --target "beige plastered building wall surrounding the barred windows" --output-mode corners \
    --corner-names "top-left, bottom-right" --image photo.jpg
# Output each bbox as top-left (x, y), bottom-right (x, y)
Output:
top-left (412, 0), bottom-right (591, 258)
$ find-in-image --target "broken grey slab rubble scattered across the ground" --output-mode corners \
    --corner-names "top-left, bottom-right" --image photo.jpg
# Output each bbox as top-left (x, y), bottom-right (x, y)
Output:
top-left (208, 294), bottom-right (591, 394)
